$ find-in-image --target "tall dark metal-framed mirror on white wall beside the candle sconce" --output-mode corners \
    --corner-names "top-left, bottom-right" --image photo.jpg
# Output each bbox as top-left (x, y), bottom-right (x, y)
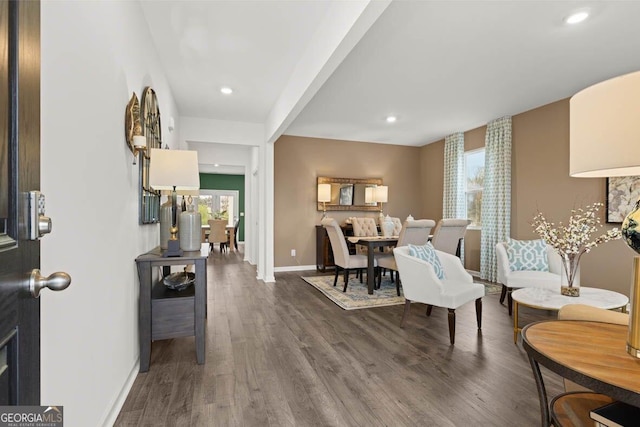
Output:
top-left (138, 86), bottom-right (162, 224)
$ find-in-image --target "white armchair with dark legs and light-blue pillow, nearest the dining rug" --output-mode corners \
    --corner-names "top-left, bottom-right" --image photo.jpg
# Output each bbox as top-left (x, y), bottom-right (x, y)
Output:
top-left (393, 244), bottom-right (485, 345)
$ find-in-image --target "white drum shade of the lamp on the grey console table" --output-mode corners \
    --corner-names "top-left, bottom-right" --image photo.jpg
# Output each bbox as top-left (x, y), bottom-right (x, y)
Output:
top-left (149, 148), bottom-right (200, 192)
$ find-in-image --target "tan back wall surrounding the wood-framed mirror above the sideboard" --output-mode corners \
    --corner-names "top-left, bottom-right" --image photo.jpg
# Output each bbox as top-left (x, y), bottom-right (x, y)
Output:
top-left (274, 135), bottom-right (422, 267)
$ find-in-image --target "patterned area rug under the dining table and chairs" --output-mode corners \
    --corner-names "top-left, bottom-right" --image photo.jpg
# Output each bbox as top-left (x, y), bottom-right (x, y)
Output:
top-left (302, 274), bottom-right (502, 310)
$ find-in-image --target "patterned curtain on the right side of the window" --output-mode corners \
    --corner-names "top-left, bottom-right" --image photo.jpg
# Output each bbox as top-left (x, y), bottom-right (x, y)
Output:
top-left (480, 116), bottom-right (511, 282)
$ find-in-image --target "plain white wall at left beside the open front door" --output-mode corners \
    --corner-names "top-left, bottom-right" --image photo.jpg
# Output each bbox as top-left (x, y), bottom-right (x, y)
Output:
top-left (41, 1), bottom-right (179, 427)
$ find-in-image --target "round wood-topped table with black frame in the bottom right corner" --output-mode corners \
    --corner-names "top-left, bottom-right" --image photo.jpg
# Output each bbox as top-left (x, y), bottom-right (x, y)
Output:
top-left (522, 320), bottom-right (640, 427)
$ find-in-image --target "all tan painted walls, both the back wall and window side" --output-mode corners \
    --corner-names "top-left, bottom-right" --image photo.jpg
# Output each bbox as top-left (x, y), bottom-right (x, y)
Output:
top-left (274, 99), bottom-right (632, 300)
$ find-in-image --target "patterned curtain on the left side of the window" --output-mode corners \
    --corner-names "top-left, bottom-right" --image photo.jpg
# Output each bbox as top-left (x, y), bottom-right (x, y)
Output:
top-left (442, 132), bottom-right (467, 265)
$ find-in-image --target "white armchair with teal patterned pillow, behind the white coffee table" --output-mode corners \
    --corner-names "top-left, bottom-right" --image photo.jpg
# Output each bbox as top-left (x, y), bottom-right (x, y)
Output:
top-left (496, 242), bottom-right (580, 316)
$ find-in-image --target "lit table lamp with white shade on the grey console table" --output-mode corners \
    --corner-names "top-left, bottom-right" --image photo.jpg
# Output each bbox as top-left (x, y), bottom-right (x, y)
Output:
top-left (149, 148), bottom-right (200, 257)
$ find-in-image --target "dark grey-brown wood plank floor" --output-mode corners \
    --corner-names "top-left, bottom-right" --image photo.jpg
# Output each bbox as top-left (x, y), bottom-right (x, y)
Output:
top-left (115, 251), bottom-right (561, 426)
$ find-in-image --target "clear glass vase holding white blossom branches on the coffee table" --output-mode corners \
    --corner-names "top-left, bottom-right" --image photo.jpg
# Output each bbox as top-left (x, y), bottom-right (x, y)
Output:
top-left (532, 203), bottom-right (622, 297)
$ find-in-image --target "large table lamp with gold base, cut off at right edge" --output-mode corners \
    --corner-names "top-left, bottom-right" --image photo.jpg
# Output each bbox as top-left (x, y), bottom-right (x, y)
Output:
top-left (569, 71), bottom-right (640, 358)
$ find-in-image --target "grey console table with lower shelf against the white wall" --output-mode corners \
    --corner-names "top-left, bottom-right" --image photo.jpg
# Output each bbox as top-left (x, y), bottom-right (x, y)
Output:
top-left (136, 247), bottom-right (207, 372)
